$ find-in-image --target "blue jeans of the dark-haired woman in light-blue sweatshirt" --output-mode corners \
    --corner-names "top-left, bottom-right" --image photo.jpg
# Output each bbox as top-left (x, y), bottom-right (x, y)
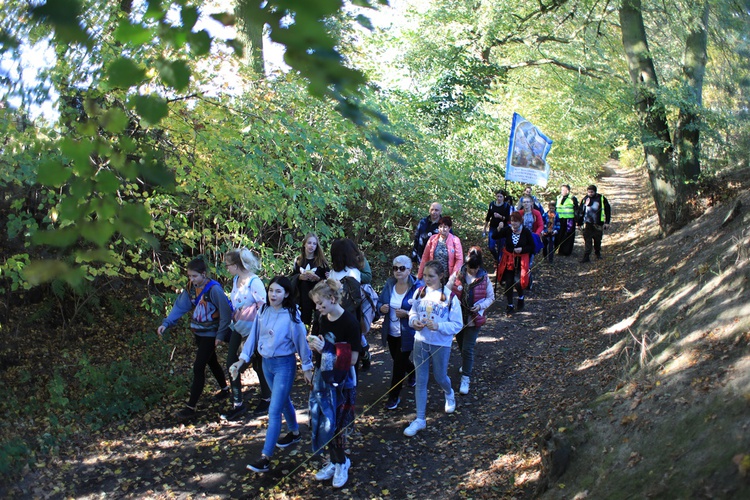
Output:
top-left (263, 354), bottom-right (299, 457)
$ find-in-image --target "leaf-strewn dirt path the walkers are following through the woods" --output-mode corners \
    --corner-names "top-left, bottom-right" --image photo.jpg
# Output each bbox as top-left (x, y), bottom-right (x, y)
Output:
top-left (4, 163), bottom-right (750, 499)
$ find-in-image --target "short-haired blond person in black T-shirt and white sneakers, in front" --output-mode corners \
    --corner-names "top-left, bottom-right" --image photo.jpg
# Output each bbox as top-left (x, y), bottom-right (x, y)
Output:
top-left (307, 278), bottom-right (361, 488)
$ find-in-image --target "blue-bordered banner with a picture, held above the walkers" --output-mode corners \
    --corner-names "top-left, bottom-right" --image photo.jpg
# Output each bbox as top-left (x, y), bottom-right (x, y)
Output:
top-left (505, 113), bottom-right (552, 187)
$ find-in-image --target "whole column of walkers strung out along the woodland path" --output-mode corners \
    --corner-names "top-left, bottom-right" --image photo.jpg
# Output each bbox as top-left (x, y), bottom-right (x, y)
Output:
top-left (157, 186), bottom-right (610, 488)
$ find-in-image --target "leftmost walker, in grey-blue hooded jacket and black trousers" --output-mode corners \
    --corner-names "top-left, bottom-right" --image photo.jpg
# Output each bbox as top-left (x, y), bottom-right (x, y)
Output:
top-left (156, 258), bottom-right (232, 420)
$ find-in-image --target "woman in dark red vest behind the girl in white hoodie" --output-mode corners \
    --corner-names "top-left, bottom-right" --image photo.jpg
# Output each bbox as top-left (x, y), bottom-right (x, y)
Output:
top-left (448, 247), bottom-right (495, 394)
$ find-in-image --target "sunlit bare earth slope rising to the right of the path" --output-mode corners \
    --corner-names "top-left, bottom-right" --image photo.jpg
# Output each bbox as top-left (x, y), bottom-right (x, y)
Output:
top-left (544, 171), bottom-right (750, 498)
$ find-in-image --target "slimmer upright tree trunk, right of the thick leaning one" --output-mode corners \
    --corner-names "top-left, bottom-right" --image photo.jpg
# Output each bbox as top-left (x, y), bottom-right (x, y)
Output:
top-left (675, 2), bottom-right (708, 186)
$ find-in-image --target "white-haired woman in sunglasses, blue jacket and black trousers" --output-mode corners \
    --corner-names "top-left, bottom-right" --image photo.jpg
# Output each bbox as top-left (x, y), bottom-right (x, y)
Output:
top-left (378, 255), bottom-right (419, 410)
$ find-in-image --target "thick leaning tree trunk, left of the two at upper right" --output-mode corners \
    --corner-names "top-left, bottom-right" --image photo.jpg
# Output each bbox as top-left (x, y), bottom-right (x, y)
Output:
top-left (619, 0), bottom-right (684, 234)
